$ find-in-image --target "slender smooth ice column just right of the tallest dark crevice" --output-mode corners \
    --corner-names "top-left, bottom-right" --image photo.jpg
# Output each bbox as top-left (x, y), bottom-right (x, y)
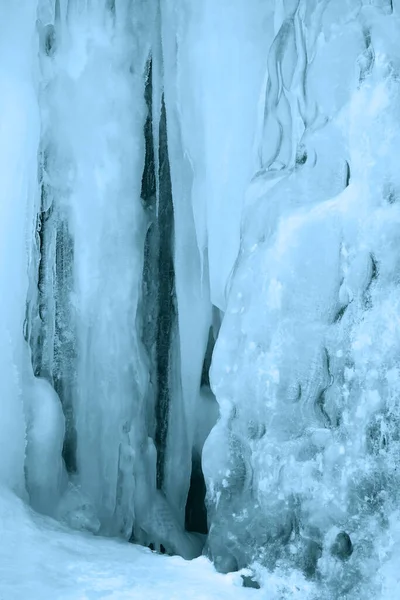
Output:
top-left (160, 1), bottom-right (211, 526)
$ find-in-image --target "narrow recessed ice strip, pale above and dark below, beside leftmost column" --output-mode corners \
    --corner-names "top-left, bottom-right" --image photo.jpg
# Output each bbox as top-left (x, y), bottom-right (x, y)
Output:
top-left (27, 2), bottom-right (76, 478)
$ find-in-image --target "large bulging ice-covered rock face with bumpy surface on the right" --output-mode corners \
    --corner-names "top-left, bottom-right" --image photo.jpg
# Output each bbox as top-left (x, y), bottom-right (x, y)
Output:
top-left (203, 1), bottom-right (400, 593)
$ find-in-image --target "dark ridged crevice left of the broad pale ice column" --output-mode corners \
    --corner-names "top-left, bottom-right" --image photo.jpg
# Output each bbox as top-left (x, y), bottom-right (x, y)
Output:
top-left (25, 150), bottom-right (76, 472)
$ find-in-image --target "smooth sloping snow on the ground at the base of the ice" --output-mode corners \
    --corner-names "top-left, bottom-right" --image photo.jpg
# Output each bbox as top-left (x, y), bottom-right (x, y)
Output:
top-left (0, 491), bottom-right (311, 600)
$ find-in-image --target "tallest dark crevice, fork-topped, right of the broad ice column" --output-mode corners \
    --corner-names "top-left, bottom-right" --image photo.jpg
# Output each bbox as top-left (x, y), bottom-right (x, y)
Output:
top-left (141, 58), bottom-right (177, 489)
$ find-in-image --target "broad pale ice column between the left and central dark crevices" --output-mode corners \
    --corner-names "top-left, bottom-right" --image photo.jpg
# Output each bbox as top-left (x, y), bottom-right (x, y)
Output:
top-left (42, 1), bottom-right (155, 537)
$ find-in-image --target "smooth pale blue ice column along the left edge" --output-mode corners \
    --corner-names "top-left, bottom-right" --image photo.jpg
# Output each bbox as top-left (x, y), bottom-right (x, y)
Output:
top-left (0, 1), bottom-right (40, 493)
